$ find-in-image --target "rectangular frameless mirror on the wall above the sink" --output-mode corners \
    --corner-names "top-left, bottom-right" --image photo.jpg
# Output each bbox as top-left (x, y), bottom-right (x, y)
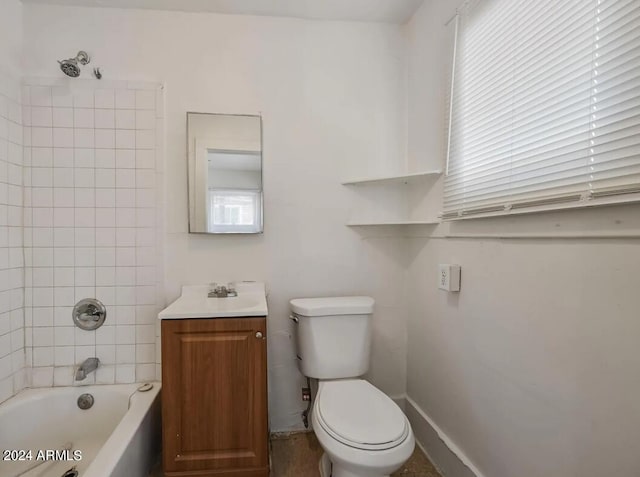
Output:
top-left (187, 113), bottom-right (263, 234)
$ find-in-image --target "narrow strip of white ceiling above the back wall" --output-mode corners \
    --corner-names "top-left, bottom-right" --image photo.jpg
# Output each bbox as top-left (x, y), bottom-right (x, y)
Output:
top-left (22, 0), bottom-right (424, 24)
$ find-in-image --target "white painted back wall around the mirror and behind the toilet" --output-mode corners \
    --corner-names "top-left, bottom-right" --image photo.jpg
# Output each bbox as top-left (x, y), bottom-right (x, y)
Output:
top-left (25, 5), bottom-right (406, 430)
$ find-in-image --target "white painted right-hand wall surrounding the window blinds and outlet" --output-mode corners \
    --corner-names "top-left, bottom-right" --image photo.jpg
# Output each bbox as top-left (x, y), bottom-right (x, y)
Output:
top-left (407, 0), bottom-right (640, 477)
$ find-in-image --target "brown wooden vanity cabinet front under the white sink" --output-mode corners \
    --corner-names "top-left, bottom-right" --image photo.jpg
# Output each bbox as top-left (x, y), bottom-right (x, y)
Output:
top-left (162, 318), bottom-right (269, 477)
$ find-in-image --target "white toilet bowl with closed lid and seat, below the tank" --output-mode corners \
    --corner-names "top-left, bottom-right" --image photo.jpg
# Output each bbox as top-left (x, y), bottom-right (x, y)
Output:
top-left (311, 379), bottom-right (415, 477)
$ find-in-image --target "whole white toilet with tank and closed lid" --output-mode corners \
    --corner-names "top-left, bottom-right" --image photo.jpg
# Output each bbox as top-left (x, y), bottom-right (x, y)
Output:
top-left (290, 296), bottom-right (415, 477)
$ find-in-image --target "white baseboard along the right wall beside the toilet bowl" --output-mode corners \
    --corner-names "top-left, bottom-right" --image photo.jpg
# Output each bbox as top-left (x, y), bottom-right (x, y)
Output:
top-left (404, 396), bottom-right (484, 477)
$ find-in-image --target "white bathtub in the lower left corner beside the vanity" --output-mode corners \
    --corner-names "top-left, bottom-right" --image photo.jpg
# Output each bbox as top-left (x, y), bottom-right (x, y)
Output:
top-left (0, 382), bottom-right (161, 477)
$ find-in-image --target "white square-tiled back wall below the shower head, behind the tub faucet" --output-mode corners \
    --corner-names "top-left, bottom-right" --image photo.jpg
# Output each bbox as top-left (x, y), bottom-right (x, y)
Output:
top-left (23, 79), bottom-right (163, 387)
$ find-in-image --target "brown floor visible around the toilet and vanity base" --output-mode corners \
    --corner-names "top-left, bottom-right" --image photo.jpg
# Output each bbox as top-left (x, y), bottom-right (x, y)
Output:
top-left (149, 432), bottom-right (441, 477)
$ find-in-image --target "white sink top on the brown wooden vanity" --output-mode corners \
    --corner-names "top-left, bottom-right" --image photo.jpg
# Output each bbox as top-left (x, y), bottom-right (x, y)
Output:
top-left (158, 282), bottom-right (268, 320)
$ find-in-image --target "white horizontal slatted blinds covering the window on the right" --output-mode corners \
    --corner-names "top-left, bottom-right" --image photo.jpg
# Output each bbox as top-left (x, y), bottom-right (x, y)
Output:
top-left (443, 0), bottom-right (640, 219)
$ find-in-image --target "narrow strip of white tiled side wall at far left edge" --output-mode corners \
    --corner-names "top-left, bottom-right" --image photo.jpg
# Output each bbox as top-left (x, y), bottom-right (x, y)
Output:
top-left (0, 72), bottom-right (26, 402)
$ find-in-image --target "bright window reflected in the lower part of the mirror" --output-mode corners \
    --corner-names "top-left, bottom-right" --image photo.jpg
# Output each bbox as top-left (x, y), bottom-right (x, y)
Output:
top-left (209, 189), bottom-right (262, 233)
